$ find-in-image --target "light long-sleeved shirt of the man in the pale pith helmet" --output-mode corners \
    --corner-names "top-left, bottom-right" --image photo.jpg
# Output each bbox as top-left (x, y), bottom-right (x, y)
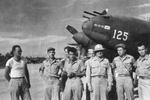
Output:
top-left (86, 57), bottom-right (112, 85)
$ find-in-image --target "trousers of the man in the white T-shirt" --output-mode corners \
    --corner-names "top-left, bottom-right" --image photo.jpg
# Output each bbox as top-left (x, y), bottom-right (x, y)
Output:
top-left (9, 78), bottom-right (31, 100)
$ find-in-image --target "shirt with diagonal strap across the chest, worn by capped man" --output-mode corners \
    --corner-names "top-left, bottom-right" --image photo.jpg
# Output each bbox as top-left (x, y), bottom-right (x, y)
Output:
top-left (112, 54), bottom-right (135, 75)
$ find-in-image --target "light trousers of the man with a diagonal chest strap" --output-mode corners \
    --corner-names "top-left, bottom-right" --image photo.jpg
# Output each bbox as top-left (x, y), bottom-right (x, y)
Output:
top-left (116, 77), bottom-right (134, 100)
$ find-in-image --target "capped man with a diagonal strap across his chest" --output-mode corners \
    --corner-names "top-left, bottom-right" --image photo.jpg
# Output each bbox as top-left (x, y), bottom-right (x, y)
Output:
top-left (112, 43), bottom-right (135, 100)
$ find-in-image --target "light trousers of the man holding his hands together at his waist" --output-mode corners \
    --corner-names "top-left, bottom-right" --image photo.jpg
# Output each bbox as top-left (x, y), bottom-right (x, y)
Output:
top-left (63, 77), bottom-right (83, 100)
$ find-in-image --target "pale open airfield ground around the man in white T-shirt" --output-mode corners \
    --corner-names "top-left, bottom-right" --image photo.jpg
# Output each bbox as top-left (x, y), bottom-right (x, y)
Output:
top-left (0, 64), bottom-right (139, 100)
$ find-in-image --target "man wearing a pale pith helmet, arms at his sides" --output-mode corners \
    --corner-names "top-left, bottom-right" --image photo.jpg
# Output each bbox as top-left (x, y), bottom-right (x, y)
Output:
top-left (87, 44), bottom-right (112, 100)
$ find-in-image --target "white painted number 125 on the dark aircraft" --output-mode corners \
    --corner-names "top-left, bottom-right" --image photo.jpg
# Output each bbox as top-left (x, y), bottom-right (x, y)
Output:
top-left (113, 30), bottom-right (129, 41)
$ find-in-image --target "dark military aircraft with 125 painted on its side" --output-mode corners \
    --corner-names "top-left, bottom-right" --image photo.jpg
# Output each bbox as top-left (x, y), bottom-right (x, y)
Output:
top-left (66, 9), bottom-right (150, 57)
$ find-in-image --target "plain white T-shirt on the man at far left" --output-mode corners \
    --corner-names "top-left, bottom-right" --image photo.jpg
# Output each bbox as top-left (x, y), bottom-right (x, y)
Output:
top-left (6, 57), bottom-right (26, 77)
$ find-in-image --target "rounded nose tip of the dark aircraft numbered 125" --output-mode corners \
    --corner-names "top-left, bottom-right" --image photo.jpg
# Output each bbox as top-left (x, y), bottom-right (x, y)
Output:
top-left (82, 20), bottom-right (93, 36)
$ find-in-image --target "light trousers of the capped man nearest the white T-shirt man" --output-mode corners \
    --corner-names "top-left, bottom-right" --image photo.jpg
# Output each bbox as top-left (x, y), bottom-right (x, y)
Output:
top-left (44, 78), bottom-right (60, 100)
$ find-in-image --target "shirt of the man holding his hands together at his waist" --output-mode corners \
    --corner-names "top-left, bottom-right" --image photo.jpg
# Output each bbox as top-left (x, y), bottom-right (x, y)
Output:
top-left (64, 59), bottom-right (85, 73)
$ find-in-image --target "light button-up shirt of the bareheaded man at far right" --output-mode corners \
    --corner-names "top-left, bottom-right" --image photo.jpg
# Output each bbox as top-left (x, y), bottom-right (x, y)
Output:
top-left (136, 54), bottom-right (150, 77)
